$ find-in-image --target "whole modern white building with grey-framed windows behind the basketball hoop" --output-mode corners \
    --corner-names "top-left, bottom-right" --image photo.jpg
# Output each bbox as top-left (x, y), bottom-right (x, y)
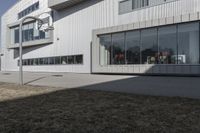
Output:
top-left (1, 0), bottom-right (200, 75)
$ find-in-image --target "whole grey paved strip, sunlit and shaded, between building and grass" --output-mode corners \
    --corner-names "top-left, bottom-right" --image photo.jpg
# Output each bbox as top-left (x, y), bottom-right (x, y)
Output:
top-left (0, 72), bottom-right (200, 99)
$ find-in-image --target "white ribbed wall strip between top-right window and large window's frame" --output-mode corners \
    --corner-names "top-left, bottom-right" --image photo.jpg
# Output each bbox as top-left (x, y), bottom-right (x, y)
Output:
top-left (119, 0), bottom-right (200, 24)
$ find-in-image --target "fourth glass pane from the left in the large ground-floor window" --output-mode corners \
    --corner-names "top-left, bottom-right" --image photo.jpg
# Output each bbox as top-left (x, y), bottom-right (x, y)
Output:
top-left (141, 28), bottom-right (158, 64)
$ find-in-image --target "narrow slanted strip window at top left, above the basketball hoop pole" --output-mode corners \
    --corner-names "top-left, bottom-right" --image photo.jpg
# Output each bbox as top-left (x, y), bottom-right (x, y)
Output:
top-left (18, 1), bottom-right (39, 19)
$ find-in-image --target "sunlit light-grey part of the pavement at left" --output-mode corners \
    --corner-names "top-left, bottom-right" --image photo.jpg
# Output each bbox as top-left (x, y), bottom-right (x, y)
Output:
top-left (0, 72), bottom-right (133, 88)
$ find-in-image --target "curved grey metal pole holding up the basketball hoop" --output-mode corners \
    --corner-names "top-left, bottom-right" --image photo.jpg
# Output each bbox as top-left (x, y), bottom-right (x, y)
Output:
top-left (19, 16), bottom-right (43, 85)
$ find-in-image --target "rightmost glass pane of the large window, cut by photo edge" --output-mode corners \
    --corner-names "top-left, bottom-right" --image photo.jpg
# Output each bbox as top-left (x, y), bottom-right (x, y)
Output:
top-left (177, 22), bottom-right (200, 64)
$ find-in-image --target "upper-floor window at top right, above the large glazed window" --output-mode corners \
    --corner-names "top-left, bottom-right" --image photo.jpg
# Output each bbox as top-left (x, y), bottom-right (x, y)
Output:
top-left (119, 0), bottom-right (175, 14)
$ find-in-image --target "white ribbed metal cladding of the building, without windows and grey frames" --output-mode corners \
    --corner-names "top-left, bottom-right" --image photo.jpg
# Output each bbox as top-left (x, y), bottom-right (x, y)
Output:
top-left (1, 0), bottom-right (200, 73)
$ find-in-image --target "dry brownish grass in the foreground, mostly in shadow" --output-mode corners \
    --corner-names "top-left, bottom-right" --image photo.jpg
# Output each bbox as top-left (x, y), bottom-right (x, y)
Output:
top-left (0, 83), bottom-right (200, 133)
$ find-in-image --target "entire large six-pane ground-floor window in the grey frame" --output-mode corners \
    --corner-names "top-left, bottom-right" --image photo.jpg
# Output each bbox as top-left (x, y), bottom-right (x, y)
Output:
top-left (99, 22), bottom-right (200, 65)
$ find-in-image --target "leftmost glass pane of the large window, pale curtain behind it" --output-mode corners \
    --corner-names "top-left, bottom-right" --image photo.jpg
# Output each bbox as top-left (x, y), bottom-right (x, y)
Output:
top-left (99, 35), bottom-right (112, 65)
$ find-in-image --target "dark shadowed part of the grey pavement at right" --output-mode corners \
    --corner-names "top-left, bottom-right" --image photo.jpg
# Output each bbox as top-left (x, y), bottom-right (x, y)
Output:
top-left (77, 76), bottom-right (200, 99)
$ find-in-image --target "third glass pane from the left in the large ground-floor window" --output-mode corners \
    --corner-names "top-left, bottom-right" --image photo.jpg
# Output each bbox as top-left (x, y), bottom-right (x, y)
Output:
top-left (125, 31), bottom-right (140, 64)
